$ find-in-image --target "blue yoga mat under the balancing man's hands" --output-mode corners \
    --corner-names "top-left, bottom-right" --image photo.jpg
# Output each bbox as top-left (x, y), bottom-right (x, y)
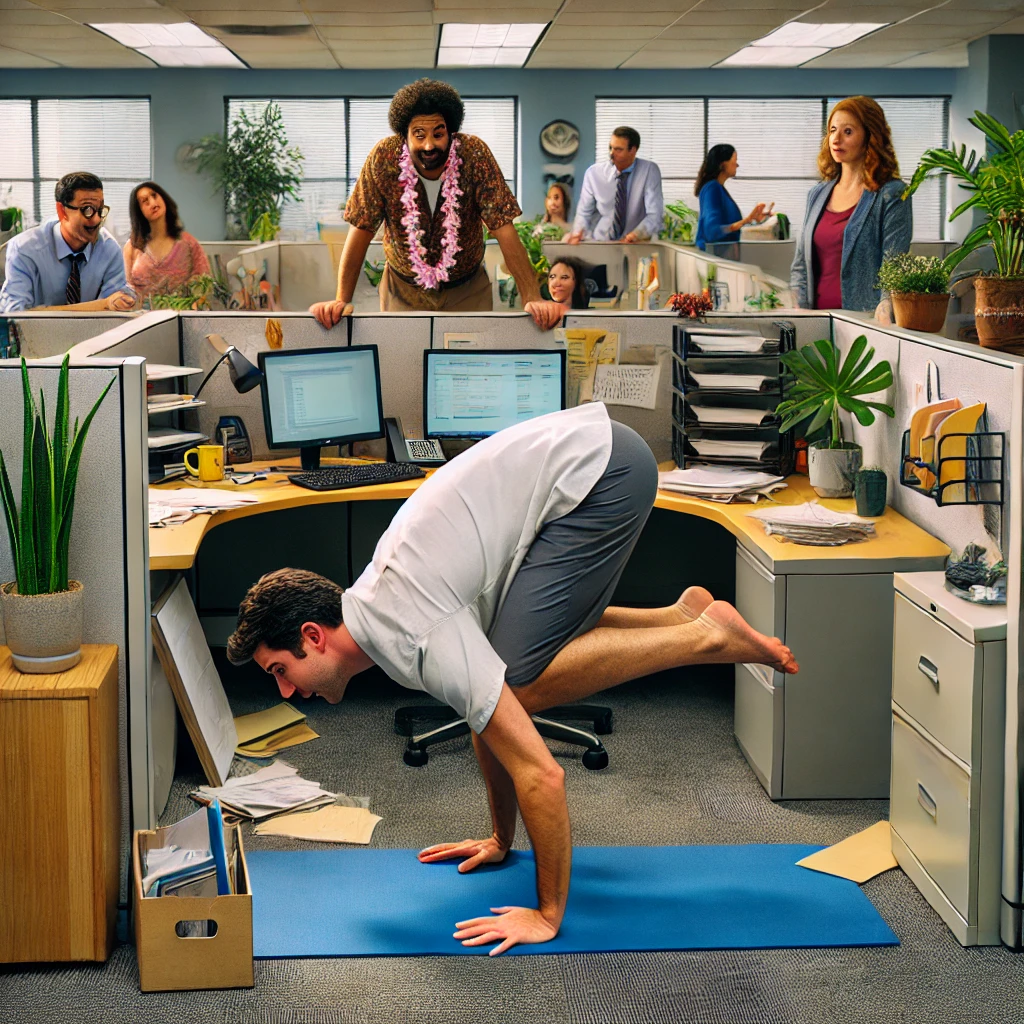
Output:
top-left (247, 845), bottom-right (899, 958)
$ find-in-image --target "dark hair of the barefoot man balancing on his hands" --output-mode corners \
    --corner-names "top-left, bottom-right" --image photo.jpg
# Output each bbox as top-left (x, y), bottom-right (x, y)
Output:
top-left (227, 569), bottom-right (343, 665)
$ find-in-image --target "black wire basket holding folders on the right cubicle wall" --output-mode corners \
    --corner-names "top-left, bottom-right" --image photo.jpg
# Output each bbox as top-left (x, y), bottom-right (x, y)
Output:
top-left (899, 430), bottom-right (1006, 506)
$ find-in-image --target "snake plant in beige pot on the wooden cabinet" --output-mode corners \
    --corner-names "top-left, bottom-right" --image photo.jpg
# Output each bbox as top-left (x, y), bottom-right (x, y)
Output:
top-left (0, 355), bottom-right (114, 674)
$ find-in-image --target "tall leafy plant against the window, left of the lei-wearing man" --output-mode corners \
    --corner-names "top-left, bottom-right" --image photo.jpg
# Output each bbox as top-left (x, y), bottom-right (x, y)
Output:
top-left (196, 103), bottom-right (304, 242)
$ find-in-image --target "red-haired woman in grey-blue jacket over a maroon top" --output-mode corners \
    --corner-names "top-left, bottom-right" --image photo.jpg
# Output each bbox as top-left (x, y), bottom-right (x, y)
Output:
top-left (790, 96), bottom-right (913, 319)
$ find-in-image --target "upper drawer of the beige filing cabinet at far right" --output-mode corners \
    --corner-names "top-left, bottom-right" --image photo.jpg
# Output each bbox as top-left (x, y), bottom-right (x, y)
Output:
top-left (893, 594), bottom-right (982, 764)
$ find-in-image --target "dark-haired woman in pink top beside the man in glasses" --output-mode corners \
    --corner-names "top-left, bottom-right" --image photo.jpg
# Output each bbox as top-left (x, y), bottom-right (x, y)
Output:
top-left (124, 181), bottom-right (210, 301)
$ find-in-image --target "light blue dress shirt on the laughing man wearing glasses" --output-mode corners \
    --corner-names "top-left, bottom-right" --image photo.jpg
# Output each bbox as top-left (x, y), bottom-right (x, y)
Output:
top-left (0, 217), bottom-right (127, 313)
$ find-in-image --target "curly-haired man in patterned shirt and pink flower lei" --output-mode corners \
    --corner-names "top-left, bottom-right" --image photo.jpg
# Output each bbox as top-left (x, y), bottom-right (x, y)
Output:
top-left (309, 78), bottom-right (563, 330)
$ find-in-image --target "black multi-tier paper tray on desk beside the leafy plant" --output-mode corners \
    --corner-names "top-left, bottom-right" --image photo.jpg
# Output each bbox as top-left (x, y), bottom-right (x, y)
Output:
top-left (672, 321), bottom-right (796, 476)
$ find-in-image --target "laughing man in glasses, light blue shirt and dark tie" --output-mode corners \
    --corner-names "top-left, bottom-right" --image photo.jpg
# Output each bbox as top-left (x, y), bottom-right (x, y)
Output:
top-left (0, 171), bottom-right (135, 313)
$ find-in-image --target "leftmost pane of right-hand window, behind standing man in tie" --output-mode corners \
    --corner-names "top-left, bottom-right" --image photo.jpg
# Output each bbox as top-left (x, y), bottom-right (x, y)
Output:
top-left (593, 99), bottom-right (705, 208)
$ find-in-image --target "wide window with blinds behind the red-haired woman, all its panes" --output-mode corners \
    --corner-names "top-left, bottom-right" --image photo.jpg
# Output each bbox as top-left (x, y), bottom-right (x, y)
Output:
top-left (595, 96), bottom-right (949, 240)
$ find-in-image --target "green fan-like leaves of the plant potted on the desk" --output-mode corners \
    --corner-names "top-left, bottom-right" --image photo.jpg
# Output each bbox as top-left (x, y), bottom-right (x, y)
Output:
top-left (775, 335), bottom-right (895, 447)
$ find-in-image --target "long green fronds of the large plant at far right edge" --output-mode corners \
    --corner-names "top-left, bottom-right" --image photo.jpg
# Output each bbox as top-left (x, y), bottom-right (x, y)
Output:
top-left (903, 111), bottom-right (1024, 278)
